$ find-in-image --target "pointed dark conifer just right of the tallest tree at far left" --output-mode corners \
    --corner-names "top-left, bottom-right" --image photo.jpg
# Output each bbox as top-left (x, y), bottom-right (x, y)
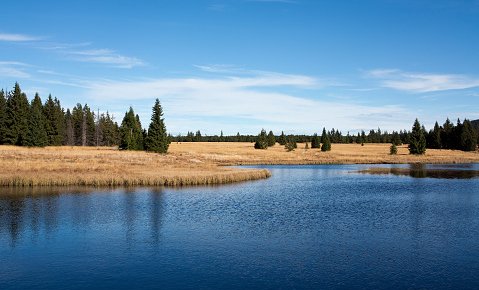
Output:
top-left (25, 93), bottom-right (48, 147)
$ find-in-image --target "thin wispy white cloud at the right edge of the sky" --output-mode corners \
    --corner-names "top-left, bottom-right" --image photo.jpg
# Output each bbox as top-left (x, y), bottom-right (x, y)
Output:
top-left (366, 69), bottom-right (479, 93)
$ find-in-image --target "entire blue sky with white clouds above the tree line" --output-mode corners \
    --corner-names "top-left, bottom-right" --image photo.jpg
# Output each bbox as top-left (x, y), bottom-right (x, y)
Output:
top-left (0, 0), bottom-right (479, 135)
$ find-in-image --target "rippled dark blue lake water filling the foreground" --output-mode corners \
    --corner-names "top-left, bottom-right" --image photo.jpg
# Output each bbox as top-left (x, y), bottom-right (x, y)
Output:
top-left (0, 165), bottom-right (479, 290)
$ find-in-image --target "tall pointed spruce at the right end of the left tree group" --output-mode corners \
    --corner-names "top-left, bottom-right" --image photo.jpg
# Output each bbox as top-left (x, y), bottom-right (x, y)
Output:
top-left (146, 99), bottom-right (170, 153)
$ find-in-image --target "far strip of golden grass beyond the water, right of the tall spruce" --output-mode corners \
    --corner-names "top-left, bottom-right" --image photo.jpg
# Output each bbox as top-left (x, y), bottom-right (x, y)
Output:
top-left (170, 142), bottom-right (479, 165)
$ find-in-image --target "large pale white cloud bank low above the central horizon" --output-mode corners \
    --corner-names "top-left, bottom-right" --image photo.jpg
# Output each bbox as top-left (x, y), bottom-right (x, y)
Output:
top-left (87, 69), bottom-right (411, 134)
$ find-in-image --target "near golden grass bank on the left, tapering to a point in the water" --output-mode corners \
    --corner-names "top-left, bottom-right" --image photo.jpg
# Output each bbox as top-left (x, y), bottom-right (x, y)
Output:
top-left (0, 146), bottom-right (270, 186)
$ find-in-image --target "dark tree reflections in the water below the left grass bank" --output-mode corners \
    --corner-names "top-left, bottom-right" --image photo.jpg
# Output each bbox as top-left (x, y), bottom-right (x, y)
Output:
top-left (0, 188), bottom-right (164, 248)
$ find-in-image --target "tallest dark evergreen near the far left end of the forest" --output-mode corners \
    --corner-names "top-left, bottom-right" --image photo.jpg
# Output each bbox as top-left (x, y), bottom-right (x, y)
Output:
top-left (4, 83), bottom-right (30, 146)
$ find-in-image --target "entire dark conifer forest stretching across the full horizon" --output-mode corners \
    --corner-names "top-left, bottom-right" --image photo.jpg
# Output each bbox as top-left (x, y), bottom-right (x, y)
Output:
top-left (0, 83), bottom-right (479, 153)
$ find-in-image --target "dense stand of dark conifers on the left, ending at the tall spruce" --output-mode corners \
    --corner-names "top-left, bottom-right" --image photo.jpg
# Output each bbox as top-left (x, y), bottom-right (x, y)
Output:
top-left (0, 83), bottom-right (169, 153)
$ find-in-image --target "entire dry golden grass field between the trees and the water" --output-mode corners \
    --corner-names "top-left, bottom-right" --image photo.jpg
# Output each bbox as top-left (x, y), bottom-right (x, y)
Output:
top-left (0, 143), bottom-right (479, 186)
